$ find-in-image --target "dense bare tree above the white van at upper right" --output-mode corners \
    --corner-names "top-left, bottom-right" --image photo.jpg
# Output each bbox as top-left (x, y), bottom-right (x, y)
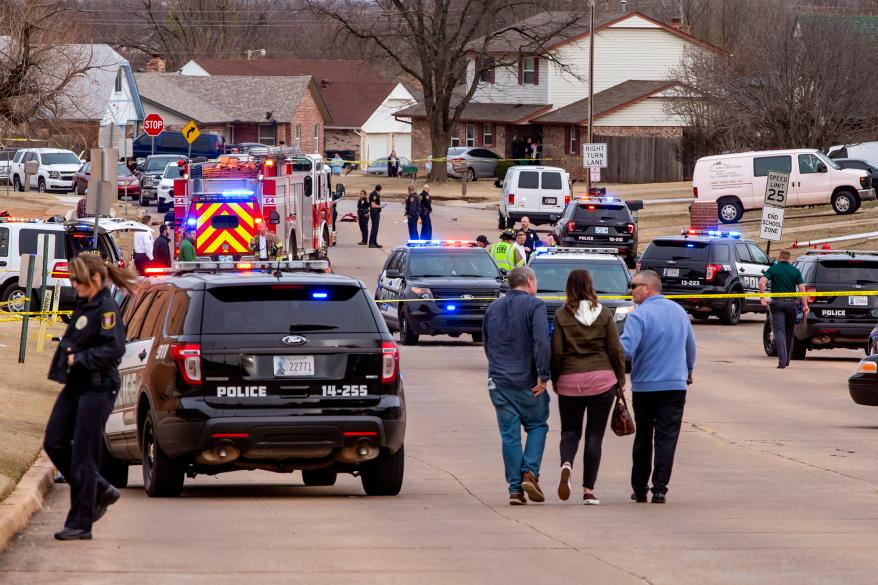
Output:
top-left (669, 2), bottom-right (878, 156)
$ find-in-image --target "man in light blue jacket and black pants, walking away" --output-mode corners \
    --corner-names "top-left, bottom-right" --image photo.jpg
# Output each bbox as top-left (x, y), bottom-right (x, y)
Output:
top-left (622, 270), bottom-right (695, 504)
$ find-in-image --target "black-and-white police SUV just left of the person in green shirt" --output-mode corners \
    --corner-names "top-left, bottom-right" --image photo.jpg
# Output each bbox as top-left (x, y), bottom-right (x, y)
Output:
top-left (637, 229), bottom-right (771, 325)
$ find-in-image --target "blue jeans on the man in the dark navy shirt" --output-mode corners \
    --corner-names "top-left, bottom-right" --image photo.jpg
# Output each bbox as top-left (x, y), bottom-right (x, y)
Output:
top-left (488, 388), bottom-right (549, 494)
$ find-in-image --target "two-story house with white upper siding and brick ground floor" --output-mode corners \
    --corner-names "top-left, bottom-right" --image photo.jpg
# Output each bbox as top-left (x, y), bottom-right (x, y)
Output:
top-left (397, 12), bottom-right (721, 180)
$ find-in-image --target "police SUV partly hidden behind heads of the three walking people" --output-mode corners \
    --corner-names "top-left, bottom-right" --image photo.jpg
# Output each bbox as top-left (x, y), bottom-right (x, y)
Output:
top-left (528, 248), bottom-right (634, 334)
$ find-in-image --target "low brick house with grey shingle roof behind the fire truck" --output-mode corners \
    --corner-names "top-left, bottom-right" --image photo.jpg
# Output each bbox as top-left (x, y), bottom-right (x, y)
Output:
top-left (135, 73), bottom-right (332, 153)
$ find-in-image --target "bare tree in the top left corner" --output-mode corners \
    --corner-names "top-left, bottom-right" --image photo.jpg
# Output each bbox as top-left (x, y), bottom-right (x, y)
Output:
top-left (0, 0), bottom-right (92, 136)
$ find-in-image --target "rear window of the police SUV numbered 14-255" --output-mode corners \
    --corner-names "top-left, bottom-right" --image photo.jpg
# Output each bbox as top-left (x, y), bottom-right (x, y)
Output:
top-left (201, 282), bottom-right (378, 335)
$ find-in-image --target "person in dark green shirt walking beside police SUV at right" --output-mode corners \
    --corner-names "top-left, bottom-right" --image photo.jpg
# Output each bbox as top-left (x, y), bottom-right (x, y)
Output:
top-left (759, 250), bottom-right (810, 368)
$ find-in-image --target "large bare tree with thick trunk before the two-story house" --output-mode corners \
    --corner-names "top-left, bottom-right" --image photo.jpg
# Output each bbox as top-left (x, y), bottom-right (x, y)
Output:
top-left (305, 0), bottom-right (583, 182)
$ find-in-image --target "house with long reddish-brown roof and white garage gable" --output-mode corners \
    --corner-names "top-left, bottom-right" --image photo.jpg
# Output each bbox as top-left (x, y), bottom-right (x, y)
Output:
top-left (180, 59), bottom-right (414, 160)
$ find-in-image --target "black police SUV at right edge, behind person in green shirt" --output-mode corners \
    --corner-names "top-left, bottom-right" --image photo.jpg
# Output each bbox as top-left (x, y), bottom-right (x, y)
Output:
top-left (763, 250), bottom-right (878, 360)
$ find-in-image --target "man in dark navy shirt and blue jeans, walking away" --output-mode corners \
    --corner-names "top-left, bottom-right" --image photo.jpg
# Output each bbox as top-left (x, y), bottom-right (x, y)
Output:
top-left (482, 266), bottom-right (551, 506)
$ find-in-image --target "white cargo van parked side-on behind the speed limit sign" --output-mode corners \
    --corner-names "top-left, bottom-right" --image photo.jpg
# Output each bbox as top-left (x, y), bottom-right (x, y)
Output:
top-left (692, 149), bottom-right (875, 223)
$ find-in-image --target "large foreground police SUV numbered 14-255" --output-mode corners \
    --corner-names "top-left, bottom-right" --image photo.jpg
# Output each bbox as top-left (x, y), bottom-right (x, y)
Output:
top-left (102, 261), bottom-right (406, 497)
